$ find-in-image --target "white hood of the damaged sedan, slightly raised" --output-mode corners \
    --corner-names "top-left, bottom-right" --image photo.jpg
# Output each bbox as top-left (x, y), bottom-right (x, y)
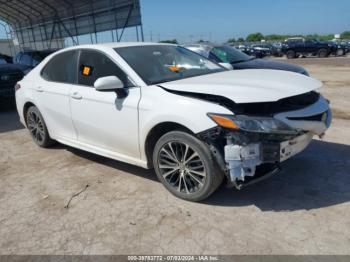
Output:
top-left (160, 69), bottom-right (322, 103)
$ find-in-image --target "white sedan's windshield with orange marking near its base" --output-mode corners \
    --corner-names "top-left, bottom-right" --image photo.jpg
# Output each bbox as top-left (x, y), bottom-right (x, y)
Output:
top-left (115, 45), bottom-right (225, 85)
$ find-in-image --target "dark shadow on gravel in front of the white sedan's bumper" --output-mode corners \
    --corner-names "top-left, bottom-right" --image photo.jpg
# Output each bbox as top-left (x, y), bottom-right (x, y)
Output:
top-left (204, 140), bottom-right (350, 211)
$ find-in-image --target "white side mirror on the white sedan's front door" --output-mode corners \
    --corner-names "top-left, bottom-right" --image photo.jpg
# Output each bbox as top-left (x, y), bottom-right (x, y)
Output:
top-left (94, 76), bottom-right (127, 98)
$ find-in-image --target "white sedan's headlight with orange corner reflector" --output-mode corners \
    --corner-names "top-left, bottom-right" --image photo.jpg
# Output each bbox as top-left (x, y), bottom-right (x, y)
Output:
top-left (208, 114), bottom-right (297, 134)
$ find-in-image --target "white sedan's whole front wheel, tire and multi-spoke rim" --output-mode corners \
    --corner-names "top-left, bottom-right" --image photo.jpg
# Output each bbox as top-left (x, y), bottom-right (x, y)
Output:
top-left (153, 131), bottom-right (224, 201)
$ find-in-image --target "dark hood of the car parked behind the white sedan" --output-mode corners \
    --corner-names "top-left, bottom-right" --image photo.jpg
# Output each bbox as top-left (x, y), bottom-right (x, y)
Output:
top-left (232, 59), bottom-right (306, 74)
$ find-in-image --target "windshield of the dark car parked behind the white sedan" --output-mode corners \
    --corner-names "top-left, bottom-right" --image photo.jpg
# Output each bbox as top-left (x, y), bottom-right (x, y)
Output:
top-left (211, 46), bottom-right (252, 64)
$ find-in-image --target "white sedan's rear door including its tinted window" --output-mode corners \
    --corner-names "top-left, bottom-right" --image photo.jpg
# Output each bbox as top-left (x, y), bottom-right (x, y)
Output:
top-left (33, 51), bottom-right (78, 140)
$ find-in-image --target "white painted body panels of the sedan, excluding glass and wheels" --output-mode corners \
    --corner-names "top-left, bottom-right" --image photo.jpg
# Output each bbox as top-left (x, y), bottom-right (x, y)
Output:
top-left (16, 43), bottom-right (330, 168)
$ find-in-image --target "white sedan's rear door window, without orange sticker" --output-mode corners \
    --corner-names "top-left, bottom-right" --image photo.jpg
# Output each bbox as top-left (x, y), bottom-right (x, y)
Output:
top-left (41, 51), bottom-right (78, 84)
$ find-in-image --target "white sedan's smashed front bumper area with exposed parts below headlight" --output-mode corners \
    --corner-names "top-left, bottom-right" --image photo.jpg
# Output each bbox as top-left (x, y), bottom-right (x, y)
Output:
top-left (201, 97), bottom-right (332, 189)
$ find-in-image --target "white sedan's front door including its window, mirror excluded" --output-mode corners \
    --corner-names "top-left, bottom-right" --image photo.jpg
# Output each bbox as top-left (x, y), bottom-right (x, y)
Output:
top-left (71, 49), bottom-right (141, 158)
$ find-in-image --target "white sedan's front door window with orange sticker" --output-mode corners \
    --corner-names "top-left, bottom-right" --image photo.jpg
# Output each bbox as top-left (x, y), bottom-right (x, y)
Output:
top-left (78, 50), bottom-right (132, 87)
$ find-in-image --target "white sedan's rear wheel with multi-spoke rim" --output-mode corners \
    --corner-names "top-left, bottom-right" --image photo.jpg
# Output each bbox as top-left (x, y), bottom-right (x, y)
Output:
top-left (26, 106), bottom-right (55, 148)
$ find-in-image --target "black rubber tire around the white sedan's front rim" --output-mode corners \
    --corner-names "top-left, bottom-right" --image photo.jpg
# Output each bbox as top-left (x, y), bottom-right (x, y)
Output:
top-left (153, 131), bottom-right (220, 201)
